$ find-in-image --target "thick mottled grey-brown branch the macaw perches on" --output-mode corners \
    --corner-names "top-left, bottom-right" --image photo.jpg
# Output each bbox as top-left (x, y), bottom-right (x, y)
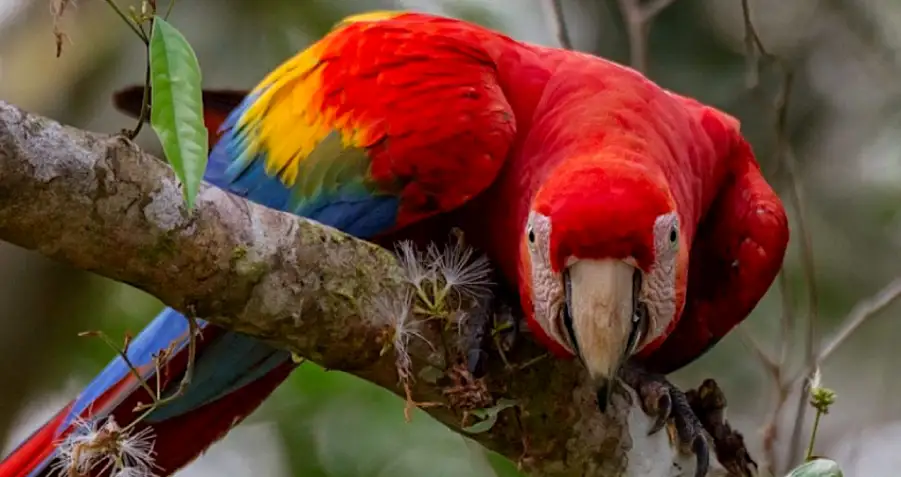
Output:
top-left (0, 98), bottom-right (693, 476)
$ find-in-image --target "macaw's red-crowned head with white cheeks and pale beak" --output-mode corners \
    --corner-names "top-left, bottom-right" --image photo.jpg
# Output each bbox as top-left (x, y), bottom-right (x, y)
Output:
top-left (520, 157), bottom-right (688, 411)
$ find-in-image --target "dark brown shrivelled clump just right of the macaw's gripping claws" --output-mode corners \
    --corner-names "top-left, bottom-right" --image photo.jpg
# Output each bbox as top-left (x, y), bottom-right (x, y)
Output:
top-left (685, 379), bottom-right (757, 477)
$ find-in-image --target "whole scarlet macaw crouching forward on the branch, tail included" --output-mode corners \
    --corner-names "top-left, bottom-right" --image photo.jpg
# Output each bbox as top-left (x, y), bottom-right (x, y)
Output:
top-left (0, 12), bottom-right (788, 477)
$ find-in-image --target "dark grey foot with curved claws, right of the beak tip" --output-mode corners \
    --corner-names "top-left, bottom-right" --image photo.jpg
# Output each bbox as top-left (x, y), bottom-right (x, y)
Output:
top-left (620, 363), bottom-right (710, 477)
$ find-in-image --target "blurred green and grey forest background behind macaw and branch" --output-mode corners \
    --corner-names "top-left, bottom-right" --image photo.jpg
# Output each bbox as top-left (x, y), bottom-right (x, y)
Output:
top-left (0, 0), bottom-right (901, 477)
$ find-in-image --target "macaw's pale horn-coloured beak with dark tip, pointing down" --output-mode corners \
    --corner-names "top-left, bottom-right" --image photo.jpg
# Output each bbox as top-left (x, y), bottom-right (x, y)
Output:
top-left (564, 260), bottom-right (640, 412)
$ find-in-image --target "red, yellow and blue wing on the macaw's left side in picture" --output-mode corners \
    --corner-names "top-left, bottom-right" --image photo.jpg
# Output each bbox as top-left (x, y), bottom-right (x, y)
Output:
top-left (207, 13), bottom-right (516, 238)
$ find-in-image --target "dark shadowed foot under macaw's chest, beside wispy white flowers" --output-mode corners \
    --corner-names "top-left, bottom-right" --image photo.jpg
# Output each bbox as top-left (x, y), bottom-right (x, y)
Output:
top-left (463, 286), bottom-right (522, 377)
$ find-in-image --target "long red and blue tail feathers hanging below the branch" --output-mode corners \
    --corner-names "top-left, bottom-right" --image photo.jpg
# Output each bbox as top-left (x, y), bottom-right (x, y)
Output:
top-left (0, 308), bottom-right (296, 477)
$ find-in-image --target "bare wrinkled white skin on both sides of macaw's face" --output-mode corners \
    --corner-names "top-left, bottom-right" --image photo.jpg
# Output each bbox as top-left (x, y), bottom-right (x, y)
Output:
top-left (525, 212), bottom-right (680, 355)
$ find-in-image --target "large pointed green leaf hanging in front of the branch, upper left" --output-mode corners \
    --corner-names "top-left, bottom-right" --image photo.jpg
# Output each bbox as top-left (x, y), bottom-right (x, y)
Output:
top-left (150, 16), bottom-right (209, 210)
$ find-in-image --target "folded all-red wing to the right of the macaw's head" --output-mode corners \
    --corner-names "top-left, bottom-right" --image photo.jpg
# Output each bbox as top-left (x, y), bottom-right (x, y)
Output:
top-left (641, 128), bottom-right (789, 373)
